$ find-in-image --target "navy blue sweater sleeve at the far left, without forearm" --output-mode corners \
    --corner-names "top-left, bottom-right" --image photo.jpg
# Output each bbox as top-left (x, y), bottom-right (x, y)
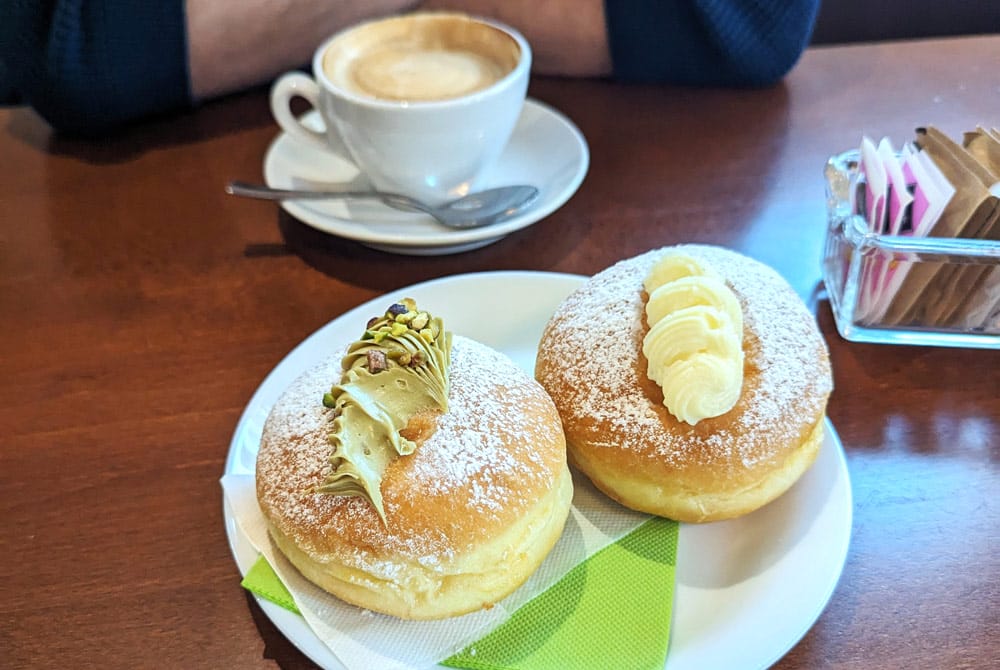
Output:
top-left (0, 0), bottom-right (191, 134)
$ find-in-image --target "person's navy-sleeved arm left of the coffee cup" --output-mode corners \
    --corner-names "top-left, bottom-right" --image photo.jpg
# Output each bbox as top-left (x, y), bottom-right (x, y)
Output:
top-left (0, 0), bottom-right (415, 135)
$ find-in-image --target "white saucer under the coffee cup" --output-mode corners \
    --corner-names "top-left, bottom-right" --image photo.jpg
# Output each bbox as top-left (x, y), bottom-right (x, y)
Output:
top-left (264, 99), bottom-right (590, 256)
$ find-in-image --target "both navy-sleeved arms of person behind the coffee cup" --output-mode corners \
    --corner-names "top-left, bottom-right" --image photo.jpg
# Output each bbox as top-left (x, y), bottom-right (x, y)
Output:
top-left (0, 0), bottom-right (819, 134)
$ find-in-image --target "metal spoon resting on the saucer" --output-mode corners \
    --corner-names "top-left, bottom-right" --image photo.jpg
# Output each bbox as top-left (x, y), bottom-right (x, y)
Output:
top-left (226, 181), bottom-right (539, 229)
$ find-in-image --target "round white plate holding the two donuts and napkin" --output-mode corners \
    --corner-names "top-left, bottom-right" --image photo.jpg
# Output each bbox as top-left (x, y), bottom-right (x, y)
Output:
top-left (225, 272), bottom-right (851, 670)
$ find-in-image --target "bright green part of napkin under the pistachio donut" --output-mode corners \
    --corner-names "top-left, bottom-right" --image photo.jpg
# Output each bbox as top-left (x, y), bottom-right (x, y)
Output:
top-left (242, 518), bottom-right (678, 670)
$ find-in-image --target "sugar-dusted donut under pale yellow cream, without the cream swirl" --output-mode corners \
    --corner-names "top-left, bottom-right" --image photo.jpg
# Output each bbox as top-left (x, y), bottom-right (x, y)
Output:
top-left (535, 245), bottom-right (833, 522)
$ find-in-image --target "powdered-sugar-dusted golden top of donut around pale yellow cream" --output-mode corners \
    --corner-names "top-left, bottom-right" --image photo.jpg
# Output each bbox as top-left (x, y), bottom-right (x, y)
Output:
top-left (538, 245), bottom-right (832, 477)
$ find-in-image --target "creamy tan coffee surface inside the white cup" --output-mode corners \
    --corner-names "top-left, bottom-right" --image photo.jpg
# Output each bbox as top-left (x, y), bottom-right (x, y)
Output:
top-left (323, 14), bottom-right (521, 102)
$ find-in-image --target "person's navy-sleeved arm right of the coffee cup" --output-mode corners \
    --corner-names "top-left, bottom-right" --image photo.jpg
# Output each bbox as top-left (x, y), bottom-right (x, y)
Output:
top-left (423, 0), bottom-right (819, 86)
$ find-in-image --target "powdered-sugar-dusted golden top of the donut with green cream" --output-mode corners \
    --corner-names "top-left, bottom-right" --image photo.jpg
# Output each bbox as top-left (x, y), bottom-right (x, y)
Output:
top-left (257, 336), bottom-right (565, 579)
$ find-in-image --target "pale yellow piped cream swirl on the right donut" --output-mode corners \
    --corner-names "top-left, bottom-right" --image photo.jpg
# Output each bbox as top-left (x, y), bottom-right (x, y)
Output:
top-left (642, 253), bottom-right (743, 426)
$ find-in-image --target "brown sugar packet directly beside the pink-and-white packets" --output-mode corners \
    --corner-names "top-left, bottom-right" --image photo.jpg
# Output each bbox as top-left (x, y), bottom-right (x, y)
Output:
top-left (884, 127), bottom-right (1000, 325)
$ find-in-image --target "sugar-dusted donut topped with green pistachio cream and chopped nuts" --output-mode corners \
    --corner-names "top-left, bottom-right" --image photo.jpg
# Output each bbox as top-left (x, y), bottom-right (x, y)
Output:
top-left (257, 303), bottom-right (573, 619)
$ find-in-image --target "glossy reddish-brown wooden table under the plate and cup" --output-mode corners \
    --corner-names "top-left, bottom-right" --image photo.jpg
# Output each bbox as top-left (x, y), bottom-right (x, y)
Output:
top-left (0, 37), bottom-right (1000, 669)
